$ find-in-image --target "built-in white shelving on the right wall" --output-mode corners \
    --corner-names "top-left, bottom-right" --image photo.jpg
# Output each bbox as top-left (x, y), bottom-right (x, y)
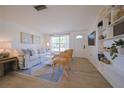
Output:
top-left (98, 6), bottom-right (124, 64)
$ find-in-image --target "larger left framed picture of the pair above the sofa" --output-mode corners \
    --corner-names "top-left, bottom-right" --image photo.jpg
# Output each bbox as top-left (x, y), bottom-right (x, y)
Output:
top-left (21, 32), bottom-right (33, 44)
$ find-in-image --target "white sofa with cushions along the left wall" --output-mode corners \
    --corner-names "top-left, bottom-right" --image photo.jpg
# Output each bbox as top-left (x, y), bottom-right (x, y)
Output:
top-left (18, 48), bottom-right (54, 69)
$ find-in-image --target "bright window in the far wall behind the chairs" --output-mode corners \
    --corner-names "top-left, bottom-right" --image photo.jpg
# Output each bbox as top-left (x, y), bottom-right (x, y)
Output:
top-left (51, 35), bottom-right (69, 51)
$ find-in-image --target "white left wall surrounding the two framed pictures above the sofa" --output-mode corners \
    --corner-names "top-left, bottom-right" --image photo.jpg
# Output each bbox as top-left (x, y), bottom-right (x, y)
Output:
top-left (0, 8), bottom-right (45, 48)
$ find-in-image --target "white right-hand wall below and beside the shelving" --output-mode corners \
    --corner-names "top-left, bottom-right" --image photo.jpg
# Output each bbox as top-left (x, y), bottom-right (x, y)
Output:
top-left (86, 18), bottom-right (124, 87)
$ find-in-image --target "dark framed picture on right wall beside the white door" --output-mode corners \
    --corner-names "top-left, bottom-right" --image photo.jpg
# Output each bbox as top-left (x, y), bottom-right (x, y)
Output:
top-left (88, 31), bottom-right (96, 46)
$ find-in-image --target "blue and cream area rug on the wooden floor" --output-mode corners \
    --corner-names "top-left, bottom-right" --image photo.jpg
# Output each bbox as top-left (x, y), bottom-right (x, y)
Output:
top-left (20, 66), bottom-right (63, 83)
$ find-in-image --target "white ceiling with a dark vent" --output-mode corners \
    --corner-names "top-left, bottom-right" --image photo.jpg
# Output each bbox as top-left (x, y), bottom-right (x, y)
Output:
top-left (0, 5), bottom-right (103, 34)
